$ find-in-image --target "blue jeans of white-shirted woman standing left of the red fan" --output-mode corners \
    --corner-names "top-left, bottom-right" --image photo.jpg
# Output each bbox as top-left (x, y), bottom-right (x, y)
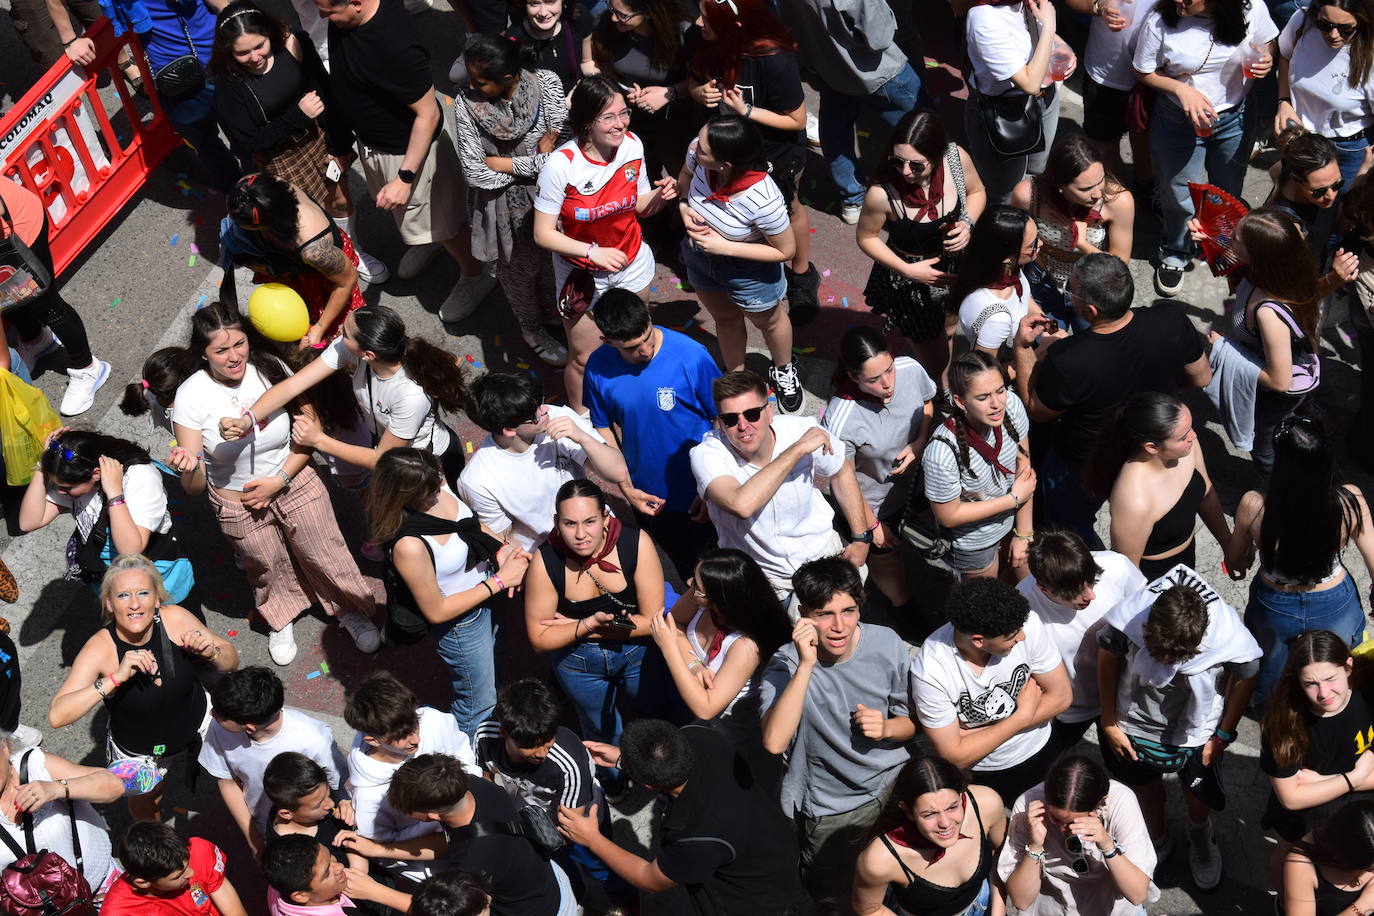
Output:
top-left (1150, 98), bottom-right (1250, 268)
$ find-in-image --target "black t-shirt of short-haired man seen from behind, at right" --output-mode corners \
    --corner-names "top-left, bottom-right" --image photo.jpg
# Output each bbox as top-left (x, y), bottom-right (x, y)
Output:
top-left (1035, 305), bottom-right (1204, 467)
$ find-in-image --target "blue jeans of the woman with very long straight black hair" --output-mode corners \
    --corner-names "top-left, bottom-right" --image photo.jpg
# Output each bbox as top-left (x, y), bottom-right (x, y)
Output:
top-left (1245, 573), bottom-right (1364, 703)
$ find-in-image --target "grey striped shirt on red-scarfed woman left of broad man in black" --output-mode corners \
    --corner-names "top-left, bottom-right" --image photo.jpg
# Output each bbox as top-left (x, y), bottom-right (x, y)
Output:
top-left (921, 391), bottom-right (1031, 551)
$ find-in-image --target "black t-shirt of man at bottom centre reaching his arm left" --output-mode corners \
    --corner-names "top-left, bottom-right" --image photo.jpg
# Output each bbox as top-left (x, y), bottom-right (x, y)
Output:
top-left (657, 725), bottom-right (804, 916)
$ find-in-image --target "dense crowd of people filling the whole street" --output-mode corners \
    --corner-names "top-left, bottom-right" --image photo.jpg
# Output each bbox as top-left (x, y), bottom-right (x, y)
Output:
top-left (0, 0), bottom-right (1374, 916)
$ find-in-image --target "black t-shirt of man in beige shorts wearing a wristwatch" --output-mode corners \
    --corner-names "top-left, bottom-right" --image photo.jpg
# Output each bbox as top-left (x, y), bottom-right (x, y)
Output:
top-left (330, 3), bottom-right (438, 155)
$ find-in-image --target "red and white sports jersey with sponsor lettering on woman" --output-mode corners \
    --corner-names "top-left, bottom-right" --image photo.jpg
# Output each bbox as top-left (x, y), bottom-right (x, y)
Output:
top-left (534, 130), bottom-right (649, 271)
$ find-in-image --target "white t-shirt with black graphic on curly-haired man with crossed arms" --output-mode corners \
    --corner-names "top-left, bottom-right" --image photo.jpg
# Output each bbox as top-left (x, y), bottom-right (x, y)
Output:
top-left (910, 614), bottom-right (1062, 770)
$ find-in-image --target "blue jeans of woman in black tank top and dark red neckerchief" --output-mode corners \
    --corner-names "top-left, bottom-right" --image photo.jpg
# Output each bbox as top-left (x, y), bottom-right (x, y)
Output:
top-left (552, 640), bottom-right (649, 744)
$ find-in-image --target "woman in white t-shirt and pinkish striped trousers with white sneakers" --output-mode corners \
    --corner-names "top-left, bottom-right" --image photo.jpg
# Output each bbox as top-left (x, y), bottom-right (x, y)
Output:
top-left (168, 302), bottom-right (381, 665)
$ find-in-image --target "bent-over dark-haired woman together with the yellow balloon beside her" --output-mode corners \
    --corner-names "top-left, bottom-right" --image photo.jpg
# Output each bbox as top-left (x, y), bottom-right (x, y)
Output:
top-left (220, 172), bottom-right (363, 349)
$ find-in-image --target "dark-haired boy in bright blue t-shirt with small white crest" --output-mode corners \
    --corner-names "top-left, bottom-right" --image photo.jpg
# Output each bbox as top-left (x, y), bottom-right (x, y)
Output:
top-left (583, 290), bottom-right (720, 580)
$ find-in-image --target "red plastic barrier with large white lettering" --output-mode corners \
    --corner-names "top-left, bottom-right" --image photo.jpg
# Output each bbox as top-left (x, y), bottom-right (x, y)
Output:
top-left (0, 19), bottom-right (180, 273)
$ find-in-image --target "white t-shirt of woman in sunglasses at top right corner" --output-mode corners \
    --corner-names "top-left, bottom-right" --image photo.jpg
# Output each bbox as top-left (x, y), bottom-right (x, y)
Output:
top-left (1279, 10), bottom-right (1374, 140)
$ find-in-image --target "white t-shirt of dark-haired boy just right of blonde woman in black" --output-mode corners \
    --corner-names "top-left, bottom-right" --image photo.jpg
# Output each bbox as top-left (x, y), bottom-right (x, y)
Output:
top-left (199, 707), bottom-right (348, 827)
